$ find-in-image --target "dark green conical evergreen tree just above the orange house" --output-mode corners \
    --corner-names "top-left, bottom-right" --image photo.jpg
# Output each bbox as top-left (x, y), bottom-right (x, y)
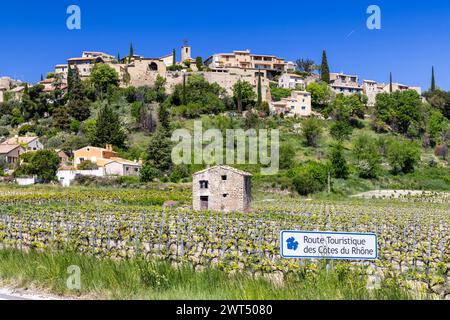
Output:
top-left (92, 105), bottom-right (126, 148)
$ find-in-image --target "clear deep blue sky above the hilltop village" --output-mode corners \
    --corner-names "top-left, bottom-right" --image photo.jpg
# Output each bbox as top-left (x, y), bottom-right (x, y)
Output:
top-left (0, 0), bottom-right (450, 90)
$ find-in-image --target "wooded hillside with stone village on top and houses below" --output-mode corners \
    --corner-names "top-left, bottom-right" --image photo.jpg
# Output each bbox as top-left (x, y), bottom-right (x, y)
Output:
top-left (0, 43), bottom-right (450, 198)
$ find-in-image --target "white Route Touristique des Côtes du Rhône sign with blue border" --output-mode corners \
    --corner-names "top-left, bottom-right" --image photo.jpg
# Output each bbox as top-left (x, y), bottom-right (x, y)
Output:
top-left (280, 230), bottom-right (378, 260)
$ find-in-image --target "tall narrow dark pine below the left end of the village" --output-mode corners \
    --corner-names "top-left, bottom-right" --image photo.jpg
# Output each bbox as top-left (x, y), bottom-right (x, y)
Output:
top-left (67, 68), bottom-right (91, 121)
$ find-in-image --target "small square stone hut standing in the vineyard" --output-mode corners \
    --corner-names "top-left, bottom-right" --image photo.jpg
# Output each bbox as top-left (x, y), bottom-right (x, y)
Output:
top-left (192, 165), bottom-right (252, 211)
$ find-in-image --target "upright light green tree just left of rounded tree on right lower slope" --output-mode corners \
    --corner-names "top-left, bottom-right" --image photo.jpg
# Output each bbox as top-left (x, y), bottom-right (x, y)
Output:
top-left (352, 134), bottom-right (381, 179)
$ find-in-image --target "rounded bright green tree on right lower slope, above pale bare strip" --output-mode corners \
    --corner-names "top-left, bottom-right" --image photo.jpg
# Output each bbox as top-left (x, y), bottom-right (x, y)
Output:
top-left (388, 139), bottom-right (420, 174)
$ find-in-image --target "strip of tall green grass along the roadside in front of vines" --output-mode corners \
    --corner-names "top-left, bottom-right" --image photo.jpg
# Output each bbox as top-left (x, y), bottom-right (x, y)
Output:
top-left (0, 250), bottom-right (412, 300)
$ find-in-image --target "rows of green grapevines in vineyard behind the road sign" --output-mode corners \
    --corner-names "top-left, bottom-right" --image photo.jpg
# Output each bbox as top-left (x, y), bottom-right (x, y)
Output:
top-left (0, 188), bottom-right (450, 298)
